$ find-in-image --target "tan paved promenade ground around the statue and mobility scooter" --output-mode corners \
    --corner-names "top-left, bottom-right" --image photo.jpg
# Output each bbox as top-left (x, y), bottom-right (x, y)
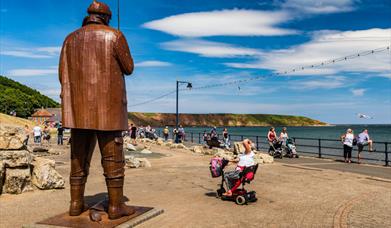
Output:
top-left (0, 142), bottom-right (391, 227)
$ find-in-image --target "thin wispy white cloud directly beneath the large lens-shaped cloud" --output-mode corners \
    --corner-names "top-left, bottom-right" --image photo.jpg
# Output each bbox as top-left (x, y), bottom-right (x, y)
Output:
top-left (161, 39), bottom-right (260, 58)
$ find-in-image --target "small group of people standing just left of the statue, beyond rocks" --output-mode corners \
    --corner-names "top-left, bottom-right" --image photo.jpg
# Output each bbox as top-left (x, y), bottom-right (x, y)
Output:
top-left (23, 122), bottom-right (64, 146)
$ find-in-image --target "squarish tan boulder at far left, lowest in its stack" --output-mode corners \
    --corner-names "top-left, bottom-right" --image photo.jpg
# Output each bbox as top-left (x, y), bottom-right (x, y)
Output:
top-left (3, 167), bottom-right (33, 194)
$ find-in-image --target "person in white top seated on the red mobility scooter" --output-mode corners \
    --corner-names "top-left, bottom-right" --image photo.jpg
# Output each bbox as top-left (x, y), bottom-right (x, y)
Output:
top-left (223, 139), bottom-right (255, 196)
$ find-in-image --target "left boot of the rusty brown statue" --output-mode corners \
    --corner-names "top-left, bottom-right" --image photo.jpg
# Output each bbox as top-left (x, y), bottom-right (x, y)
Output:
top-left (69, 178), bottom-right (85, 216)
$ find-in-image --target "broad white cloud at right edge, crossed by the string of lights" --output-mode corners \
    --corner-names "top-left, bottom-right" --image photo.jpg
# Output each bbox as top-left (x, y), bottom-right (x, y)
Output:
top-left (226, 29), bottom-right (391, 75)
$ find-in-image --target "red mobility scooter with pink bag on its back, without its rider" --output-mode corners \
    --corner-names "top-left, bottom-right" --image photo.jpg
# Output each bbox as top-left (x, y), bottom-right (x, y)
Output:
top-left (210, 158), bottom-right (258, 205)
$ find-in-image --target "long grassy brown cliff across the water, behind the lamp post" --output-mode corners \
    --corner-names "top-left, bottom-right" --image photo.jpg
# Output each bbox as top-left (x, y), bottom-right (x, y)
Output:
top-left (128, 112), bottom-right (328, 127)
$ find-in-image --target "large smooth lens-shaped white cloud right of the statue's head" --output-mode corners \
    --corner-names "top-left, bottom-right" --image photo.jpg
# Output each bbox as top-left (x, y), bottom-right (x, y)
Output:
top-left (143, 9), bottom-right (297, 37)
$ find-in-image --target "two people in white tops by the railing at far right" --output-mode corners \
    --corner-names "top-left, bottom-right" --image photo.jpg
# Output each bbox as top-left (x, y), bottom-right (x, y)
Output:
top-left (341, 128), bottom-right (374, 163)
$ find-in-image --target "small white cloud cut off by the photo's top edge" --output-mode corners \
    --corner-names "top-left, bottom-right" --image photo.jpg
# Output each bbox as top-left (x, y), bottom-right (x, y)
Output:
top-left (280, 0), bottom-right (356, 14)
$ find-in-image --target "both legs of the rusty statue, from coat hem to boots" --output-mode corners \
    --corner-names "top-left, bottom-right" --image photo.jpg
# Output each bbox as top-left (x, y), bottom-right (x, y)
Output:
top-left (69, 129), bottom-right (134, 219)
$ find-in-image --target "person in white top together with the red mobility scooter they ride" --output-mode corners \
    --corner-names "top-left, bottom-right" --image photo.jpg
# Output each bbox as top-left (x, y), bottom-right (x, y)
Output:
top-left (211, 139), bottom-right (258, 205)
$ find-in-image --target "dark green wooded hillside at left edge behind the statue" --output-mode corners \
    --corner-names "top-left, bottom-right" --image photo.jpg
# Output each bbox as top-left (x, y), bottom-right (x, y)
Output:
top-left (0, 75), bottom-right (59, 118)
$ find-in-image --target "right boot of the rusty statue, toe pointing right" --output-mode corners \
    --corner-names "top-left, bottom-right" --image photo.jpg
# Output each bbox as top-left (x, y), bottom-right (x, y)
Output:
top-left (106, 178), bottom-right (136, 219)
